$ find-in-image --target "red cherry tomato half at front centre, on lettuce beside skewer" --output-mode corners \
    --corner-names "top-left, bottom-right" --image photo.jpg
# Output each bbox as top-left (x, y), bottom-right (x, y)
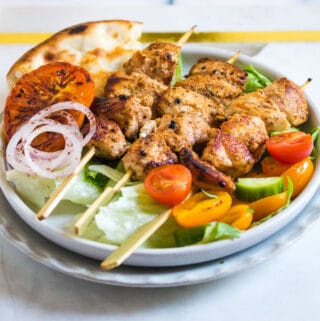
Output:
top-left (144, 164), bottom-right (192, 205)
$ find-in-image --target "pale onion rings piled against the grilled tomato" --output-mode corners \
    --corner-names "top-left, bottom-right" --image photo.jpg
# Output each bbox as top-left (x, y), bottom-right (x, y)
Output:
top-left (6, 102), bottom-right (96, 178)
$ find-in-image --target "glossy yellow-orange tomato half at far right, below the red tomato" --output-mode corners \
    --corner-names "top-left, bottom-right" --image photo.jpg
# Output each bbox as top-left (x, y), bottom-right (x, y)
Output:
top-left (282, 157), bottom-right (314, 197)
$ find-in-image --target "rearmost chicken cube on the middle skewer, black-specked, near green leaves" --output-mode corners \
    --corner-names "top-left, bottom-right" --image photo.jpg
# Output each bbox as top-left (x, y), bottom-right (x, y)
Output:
top-left (189, 58), bottom-right (247, 87)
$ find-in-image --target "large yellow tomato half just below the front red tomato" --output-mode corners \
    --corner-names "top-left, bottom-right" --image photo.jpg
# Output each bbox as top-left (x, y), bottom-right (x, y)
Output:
top-left (172, 192), bottom-right (232, 228)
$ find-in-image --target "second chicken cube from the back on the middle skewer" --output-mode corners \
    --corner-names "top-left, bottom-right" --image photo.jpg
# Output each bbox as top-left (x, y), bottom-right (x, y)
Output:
top-left (176, 74), bottom-right (243, 110)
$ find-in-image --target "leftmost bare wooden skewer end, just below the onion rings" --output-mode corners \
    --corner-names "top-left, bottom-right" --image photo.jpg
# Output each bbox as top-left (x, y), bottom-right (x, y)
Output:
top-left (37, 147), bottom-right (96, 220)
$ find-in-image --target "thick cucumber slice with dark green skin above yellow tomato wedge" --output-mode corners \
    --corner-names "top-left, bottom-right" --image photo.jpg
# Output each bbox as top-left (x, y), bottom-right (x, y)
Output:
top-left (236, 177), bottom-right (284, 202)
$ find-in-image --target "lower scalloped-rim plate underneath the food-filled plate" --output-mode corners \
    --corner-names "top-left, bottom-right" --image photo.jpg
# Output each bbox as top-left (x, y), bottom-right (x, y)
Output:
top-left (0, 184), bottom-right (320, 287)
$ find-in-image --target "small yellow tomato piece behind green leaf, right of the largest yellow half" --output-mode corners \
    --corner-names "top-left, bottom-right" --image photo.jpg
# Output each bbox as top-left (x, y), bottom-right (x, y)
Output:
top-left (218, 204), bottom-right (253, 230)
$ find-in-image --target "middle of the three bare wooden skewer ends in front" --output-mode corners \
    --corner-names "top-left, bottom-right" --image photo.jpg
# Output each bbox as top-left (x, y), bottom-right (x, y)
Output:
top-left (74, 170), bottom-right (132, 235)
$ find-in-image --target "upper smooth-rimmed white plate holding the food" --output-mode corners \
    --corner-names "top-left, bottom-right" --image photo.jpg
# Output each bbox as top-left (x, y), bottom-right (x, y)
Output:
top-left (0, 46), bottom-right (320, 267)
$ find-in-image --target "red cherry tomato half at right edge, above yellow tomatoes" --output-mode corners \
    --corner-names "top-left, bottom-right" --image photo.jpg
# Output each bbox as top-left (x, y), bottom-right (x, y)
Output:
top-left (266, 131), bottom-right (313, 164)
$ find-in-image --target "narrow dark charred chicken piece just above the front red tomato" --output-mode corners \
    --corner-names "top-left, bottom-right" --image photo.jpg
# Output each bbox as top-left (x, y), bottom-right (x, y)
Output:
top-left (179, 147), bottom-right (235, 192)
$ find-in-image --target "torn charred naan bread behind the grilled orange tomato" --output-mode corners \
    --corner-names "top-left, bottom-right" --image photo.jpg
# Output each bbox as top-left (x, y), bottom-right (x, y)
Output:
top-left (7, 20), bottom-right (142, 96)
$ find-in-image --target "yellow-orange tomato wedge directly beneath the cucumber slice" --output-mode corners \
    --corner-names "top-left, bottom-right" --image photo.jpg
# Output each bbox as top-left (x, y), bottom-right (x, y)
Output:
top-left (249, 191), bottom-right (288, 222)
